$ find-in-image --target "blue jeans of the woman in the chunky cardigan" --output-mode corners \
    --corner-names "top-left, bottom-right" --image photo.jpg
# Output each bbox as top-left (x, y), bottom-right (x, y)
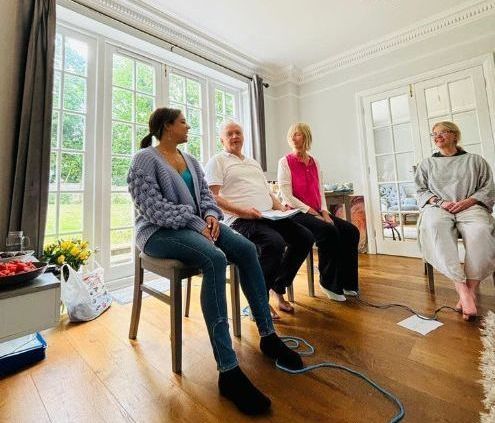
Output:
top-left (144, 224), bottom-right (275, 372)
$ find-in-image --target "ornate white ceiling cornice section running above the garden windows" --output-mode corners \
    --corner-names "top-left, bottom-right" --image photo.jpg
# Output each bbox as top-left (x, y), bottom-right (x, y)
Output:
top-left (73, 0), bottom-right (274, 79)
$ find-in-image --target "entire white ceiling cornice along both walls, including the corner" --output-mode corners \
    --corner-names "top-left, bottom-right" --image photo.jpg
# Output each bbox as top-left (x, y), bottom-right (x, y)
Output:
top-left (66, 0), bottom-right (495, 85)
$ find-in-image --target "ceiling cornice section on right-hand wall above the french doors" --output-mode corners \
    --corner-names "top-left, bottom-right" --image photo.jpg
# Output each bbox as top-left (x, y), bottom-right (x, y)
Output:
top-left (298, 0), bottom-right (495, 84)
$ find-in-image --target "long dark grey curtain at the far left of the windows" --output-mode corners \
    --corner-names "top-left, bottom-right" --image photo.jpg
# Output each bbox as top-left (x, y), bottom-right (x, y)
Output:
top-left (6, 0), bottom-right (56, 253)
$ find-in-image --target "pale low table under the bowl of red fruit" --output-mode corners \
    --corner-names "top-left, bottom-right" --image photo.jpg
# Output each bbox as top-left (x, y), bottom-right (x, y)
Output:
top-left (0, 273), bottom-right (60, 342)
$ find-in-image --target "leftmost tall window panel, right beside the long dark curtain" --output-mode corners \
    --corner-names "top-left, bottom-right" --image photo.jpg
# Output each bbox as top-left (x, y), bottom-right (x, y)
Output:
top-left (45, 31), bottom-right (92, 242)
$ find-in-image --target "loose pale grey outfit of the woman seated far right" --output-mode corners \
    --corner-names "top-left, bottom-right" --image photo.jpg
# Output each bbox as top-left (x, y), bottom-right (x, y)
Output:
top-left (415, 153), bottom-right (495, 282)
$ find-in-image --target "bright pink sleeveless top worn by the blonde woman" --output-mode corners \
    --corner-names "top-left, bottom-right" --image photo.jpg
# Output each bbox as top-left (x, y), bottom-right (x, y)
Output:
top-left (285, 153), bottom-right (321, 212)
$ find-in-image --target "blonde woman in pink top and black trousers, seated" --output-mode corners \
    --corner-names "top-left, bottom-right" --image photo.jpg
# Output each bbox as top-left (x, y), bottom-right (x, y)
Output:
top-left (278, 123), bottom-right (359, 301)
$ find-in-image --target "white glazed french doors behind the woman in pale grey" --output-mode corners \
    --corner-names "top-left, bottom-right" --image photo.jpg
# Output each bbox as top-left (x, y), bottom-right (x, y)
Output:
top-left (363, 66), bottom-right (495, 257)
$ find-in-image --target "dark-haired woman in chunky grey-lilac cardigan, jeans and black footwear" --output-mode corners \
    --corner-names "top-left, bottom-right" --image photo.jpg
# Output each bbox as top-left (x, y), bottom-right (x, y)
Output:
top-left (127, 108), bottom-right (303, 414)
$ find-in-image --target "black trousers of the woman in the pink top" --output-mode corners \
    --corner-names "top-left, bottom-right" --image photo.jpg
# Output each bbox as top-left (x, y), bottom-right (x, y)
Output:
top-left (292, 213), bottom-right (359, 294)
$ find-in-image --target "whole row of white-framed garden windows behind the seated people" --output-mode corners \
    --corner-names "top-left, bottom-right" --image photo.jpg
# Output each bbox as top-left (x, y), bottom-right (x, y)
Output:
top-left (45, 21), bottom-right (247, 280)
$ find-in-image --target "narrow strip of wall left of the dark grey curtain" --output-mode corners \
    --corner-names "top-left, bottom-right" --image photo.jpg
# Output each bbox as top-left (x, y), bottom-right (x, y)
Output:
top-left (0, 1), bottom-right (21, 250)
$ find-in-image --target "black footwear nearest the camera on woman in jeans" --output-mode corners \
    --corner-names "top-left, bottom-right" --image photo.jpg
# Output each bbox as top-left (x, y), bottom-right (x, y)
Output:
top-left (218, 366), bottom-right (272, 416)
